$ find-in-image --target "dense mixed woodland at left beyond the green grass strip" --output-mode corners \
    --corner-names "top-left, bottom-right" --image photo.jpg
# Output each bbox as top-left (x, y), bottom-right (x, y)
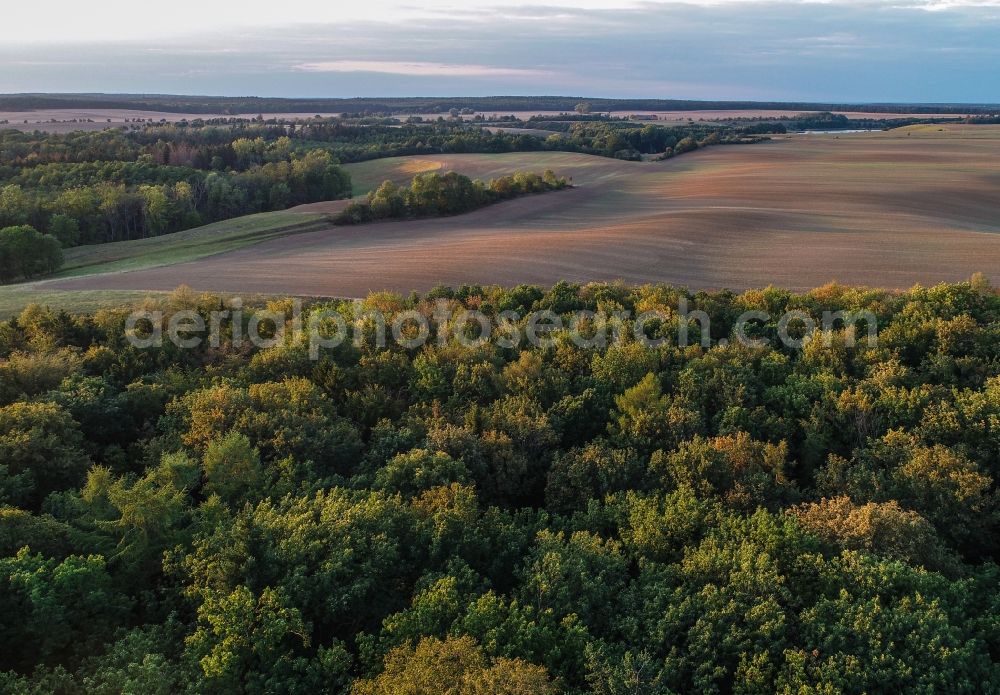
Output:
top-left (0, 126), bottom-right (351, 246)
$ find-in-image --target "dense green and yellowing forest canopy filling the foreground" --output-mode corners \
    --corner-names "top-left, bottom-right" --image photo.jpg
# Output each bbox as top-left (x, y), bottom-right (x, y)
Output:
top-left (0, 277), bottom-right (1000, 695)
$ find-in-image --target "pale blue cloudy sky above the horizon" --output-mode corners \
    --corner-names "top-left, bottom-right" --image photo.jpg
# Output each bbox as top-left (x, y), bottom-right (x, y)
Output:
top-left (0, 0), bottom-right (1000, 103)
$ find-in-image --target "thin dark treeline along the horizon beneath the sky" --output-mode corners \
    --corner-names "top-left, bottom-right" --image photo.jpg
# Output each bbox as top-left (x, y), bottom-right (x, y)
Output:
top-left (0, 94), bottom-right (1000, 115)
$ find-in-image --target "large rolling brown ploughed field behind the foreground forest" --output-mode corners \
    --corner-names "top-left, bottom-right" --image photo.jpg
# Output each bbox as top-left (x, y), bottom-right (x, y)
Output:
top-left (27, 125), bottom-right (1000, 304)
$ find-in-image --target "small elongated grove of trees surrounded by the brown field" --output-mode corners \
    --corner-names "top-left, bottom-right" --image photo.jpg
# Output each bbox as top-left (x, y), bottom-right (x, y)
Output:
top-left (335, 169), bottom-right (569, 224)
